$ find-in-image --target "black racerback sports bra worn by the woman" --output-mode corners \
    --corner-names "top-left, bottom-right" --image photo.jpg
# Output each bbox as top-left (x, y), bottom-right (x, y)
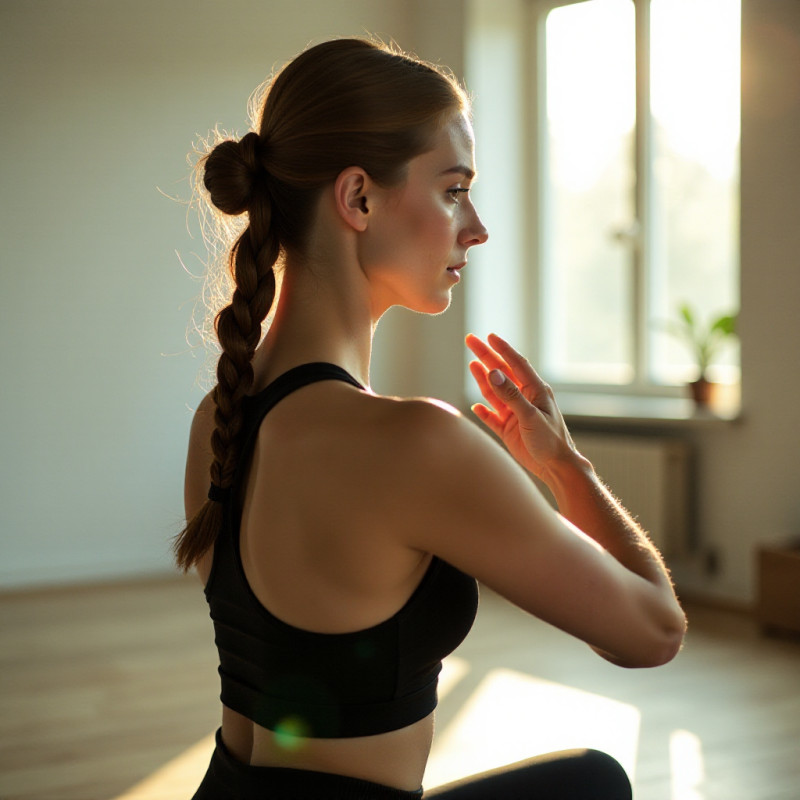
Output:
top-left (206, 363), bottom-right (478, 738)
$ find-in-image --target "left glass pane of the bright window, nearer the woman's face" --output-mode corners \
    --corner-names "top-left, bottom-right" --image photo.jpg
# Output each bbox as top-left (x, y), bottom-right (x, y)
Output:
top-left (541, 0), bottom-right (636, 383)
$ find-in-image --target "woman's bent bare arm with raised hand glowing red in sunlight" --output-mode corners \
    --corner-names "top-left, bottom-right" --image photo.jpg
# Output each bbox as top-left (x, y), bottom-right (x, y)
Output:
top-left (382, 337), bottom-right (686, 667)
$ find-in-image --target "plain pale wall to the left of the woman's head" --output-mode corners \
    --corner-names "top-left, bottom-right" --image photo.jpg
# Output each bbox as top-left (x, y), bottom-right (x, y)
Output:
top-left (0, 0), bottom-right (410, 586)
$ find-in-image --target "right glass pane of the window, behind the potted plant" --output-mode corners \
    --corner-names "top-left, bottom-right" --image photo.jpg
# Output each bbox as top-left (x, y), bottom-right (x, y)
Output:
top-left (649, 0), bottom-right (741, 383)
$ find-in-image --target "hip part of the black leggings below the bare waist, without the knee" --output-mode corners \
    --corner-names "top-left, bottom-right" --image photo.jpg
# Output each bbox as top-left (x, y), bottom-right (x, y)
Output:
top-left (194, 729), bottom-right (422, 800)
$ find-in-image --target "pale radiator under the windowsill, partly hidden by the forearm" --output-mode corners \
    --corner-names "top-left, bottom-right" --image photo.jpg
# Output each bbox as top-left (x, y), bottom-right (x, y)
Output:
top-left (573, 432), bottom-right (693, 556)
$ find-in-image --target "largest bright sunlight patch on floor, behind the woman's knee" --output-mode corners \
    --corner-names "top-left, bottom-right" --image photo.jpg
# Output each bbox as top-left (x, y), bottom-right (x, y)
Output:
top-left (424, 669), bottom-right (644, 800)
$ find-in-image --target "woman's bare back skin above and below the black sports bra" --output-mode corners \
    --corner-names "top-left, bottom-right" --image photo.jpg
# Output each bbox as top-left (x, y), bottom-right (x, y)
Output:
top-left (187, 381), bottom-right (446, 790)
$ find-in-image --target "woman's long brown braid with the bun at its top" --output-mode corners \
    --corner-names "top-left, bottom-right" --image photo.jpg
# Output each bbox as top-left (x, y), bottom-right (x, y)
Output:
top-left (175, 133), bottom-right (280, 570)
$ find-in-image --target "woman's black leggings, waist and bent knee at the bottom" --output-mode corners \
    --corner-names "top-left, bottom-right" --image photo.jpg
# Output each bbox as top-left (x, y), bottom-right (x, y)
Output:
top-left (192, 731), bottom-right (632, 800)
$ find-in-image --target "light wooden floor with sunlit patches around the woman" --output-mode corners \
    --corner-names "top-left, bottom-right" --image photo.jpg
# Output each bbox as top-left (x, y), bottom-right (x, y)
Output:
top-left (0, 578), bottom-right (800, 800)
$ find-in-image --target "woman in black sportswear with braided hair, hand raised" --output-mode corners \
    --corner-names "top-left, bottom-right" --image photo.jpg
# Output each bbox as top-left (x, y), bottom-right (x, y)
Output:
top-left (176, 34), bottom-right (685, 800)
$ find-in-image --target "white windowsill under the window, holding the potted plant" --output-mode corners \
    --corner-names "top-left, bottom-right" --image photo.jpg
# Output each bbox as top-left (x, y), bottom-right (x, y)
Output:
top-left (556, 391), bottom-right (741, 427)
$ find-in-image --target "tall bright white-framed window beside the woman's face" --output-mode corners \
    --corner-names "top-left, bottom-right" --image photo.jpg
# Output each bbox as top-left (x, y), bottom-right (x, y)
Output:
top-left (467, 0), bottom-right (740, 394)
